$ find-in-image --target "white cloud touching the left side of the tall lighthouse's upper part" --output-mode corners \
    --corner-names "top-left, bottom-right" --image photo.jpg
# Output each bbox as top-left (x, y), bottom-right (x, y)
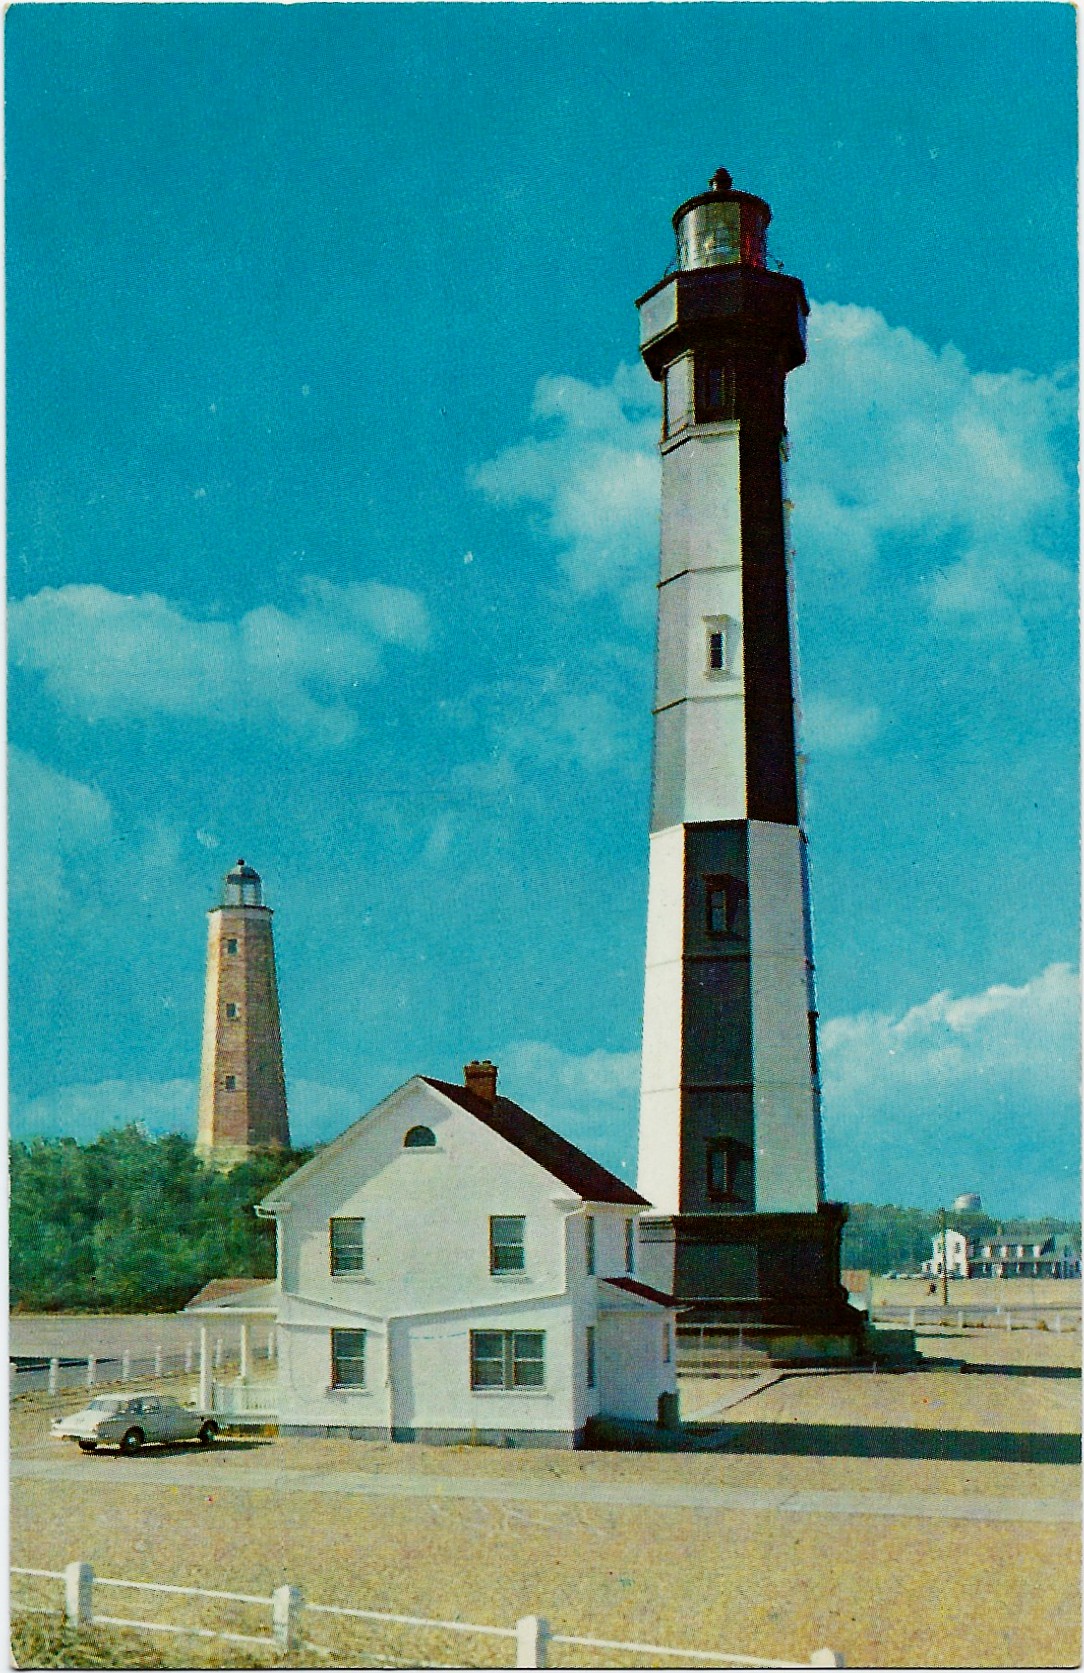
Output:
top-left (472, 366), bottom-right (659, 609)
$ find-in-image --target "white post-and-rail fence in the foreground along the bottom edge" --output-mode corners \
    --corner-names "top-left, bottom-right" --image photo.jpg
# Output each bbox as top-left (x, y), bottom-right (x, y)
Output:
top-left (12, 1563), bottom-right (845, 1668)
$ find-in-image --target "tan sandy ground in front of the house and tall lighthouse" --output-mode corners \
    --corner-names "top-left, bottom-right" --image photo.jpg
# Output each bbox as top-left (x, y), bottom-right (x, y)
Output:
top-left (12, 1332), bottom-right (1079, 1668)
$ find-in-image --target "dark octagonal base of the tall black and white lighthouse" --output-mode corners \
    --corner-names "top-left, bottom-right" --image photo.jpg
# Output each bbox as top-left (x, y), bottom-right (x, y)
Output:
top-left (639, 1203), bottom-right (867, 1372)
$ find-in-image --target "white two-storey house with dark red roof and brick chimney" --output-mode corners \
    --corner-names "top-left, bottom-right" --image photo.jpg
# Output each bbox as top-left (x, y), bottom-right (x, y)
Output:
top-left (244, 1062), bottom-right (676, 1447)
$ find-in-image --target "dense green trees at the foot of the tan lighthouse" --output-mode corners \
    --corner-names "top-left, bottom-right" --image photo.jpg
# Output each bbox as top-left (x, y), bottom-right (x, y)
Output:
top-left (8, 1126), bottom-right (313, 1312)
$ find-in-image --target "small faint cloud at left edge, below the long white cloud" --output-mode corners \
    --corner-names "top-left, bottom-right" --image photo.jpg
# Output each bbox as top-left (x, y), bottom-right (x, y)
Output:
top-left (8, 744), bottom-right (112, 908)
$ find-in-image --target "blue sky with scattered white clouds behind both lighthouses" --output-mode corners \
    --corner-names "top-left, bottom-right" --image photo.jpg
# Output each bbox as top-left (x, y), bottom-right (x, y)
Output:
top-left (5, 0), bottom-right (1079, 1216)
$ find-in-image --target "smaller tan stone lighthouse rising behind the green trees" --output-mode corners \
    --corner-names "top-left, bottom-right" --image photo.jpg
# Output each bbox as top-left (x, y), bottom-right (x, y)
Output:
top-left (196, 860), bottom-right (289, 1168)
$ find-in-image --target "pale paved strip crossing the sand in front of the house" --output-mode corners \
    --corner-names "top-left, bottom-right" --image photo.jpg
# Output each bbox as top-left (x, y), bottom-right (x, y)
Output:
top-left (10, 1454), bottom-right (1081, 1522)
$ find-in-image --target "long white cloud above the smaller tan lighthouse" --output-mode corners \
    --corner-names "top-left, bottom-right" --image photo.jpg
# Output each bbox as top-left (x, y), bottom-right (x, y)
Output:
top-left (8, 576), bottom-right (428, 746)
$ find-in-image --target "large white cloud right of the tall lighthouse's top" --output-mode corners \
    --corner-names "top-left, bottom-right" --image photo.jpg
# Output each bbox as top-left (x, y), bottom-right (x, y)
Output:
top-left (788, 303), bottom-right (1076, 631)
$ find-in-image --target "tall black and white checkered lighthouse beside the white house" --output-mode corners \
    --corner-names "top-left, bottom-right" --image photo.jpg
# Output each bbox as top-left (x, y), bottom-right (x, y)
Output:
top-left (637, 169), bottom-right (860, 1353)
